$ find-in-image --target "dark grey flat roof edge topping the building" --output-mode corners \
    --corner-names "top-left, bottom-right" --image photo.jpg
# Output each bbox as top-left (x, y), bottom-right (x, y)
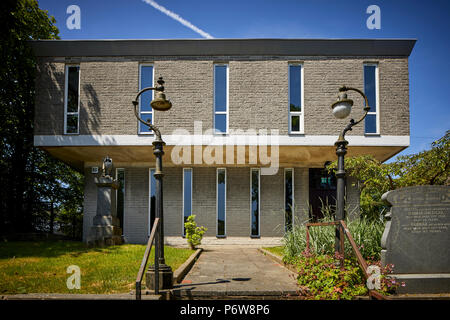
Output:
top-left (30, 39), bottom-right (416, 57)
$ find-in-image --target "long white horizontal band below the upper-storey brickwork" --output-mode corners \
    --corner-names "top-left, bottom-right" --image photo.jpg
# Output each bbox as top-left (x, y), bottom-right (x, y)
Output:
top-left (34, 135), bottom-right (410, 147)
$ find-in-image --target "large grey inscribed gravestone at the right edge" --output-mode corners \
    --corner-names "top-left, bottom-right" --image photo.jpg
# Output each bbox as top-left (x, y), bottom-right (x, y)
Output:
top-left (381, 186), bottom-right (450, 293)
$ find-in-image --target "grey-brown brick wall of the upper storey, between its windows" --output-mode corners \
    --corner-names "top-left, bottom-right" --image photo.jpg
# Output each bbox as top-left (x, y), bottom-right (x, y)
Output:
top-left (35, 57), bottom-right (409, 135)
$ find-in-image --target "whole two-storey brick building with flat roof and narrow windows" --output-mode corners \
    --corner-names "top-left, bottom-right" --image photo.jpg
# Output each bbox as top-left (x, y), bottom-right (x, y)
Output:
top-left (32, 39), bottom-right (415, 244)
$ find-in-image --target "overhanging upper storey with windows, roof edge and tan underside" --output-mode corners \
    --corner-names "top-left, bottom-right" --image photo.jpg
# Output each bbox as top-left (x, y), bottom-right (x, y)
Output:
top-left (30, 39), bottom-right (416, 168)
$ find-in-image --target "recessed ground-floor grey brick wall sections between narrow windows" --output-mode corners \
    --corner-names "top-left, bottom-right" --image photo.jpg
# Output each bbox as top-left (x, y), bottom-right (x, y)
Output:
top-left (83, 167), bottom-right (334, 243)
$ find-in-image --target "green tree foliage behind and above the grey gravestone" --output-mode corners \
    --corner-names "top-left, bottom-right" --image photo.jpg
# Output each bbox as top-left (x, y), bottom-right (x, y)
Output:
top-left (328, 130), bottom-right (450, 217)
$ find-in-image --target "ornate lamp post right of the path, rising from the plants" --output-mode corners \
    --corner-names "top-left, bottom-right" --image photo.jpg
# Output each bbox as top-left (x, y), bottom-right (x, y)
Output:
top-left (331, 86), bottom-right (370, 254)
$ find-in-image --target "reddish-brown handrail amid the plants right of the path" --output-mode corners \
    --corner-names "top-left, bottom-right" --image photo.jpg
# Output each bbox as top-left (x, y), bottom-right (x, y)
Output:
top-left (306, 220), bottom-right (386, 300)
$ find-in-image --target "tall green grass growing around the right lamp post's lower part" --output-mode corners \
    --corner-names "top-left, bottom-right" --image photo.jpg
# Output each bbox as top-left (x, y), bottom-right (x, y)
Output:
top-left (283, 206), bottom-right (384, 263)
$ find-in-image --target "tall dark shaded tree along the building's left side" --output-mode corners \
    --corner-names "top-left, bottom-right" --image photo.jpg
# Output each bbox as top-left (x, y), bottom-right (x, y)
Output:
top-left (0, 0), bottom-right (82, 234)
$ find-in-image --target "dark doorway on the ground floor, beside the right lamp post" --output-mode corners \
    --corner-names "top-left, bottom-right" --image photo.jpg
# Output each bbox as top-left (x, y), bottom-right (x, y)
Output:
top-left (309, 168), bottom-right (336, 221)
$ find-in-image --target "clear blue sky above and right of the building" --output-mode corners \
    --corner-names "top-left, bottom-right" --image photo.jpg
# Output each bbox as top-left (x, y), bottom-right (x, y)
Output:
top-left (38, 0), bottom-right (450, 160)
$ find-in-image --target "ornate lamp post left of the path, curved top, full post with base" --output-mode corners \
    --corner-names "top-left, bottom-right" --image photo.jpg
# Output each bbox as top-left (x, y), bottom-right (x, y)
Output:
top-left (133, 77), bottom-right (173, 289)
